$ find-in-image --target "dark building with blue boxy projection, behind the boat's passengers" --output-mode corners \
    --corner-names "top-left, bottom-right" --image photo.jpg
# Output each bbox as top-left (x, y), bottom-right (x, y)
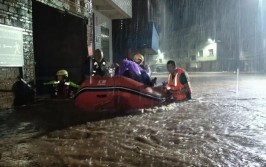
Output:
top-left (113, 0), bottom-right (160, 63)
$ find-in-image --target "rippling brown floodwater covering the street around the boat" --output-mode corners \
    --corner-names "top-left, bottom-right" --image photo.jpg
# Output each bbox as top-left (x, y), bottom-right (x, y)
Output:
top-left (0, 73), bottom-right (266, 167)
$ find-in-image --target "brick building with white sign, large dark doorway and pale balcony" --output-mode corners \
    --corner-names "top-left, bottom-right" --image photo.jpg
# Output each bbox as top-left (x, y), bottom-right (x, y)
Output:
top-left (0, 0), bottom-right (132, 109)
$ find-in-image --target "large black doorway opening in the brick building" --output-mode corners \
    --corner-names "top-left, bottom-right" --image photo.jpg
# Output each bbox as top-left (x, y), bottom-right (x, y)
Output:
top-left (32, 1), bottom-right (88, 94)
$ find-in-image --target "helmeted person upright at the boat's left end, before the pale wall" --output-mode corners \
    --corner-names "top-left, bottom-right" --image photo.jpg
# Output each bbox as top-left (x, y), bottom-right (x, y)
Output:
top-left (92, 49), bottom-right (109, 77)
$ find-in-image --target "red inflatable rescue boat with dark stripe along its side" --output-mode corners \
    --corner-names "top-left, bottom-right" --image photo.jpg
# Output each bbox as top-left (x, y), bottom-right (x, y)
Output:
top-left (75, 76), bottom-right (165, 111)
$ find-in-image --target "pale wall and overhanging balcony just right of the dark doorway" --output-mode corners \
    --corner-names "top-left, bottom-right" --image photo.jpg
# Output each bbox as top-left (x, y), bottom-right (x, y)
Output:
top-left (92, 0), bottom-right (132, 64)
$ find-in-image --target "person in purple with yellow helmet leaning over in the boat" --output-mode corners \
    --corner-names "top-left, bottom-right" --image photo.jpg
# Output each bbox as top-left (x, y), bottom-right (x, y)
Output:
top-left (118, 53), bottom-right (157, 86)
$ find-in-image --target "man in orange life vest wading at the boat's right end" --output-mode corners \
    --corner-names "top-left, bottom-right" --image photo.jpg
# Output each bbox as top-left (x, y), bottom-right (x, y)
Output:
top-left (164, 60), bottom-right (191, 101)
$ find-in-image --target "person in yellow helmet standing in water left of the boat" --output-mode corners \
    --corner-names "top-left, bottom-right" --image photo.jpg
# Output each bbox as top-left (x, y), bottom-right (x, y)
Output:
top-left (44, 69), bottom-right (79, 99)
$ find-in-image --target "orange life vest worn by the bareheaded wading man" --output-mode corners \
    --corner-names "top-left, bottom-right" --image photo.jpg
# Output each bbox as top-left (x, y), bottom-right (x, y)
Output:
top-left (167, 68), bottom-right (191, 100)
